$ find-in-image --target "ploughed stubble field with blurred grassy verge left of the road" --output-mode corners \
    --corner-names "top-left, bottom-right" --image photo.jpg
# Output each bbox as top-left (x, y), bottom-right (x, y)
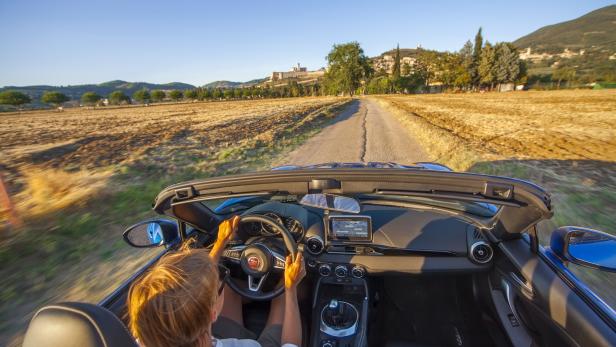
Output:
top-left (0, 97), bottom-right (350, 346)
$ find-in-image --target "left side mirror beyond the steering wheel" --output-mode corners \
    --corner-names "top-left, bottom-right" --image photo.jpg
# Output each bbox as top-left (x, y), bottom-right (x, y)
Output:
top-left (123, 219), bottom-right (180, 248)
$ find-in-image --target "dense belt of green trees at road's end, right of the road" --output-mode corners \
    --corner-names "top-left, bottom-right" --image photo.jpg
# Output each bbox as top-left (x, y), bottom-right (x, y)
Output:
top-left (323, 28), bottom-right (526, 95)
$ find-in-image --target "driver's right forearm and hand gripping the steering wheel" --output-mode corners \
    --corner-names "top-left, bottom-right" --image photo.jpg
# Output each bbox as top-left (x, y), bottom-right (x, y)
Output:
top-left (280, 253), bottom-right (306, 346)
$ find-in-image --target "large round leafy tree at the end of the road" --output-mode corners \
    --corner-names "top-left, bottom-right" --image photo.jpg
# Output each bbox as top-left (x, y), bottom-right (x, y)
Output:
top-left (324, 42), bottom-right (371, 95)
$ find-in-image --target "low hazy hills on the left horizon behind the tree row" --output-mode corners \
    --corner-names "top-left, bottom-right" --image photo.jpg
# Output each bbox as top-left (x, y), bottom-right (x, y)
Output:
top-left (0, 80), bottom-right (195, 105)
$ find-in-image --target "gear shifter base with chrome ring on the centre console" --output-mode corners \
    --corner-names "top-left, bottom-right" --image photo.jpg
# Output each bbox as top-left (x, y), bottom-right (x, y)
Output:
top-left (320, 299), bottom-right (359, 337)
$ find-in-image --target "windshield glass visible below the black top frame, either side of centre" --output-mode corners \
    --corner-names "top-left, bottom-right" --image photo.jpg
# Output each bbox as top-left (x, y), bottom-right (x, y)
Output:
top-left (201, 194), bottom-right (499, 218)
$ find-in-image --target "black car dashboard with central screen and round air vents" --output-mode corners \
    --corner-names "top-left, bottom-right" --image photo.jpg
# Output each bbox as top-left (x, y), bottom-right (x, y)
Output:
top-left (240, 202), bottom-right (494, 277)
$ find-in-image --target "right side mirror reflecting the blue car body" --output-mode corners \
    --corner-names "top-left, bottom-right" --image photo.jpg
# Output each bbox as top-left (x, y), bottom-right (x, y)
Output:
top-left (550, 226), bottom-right (616, 272)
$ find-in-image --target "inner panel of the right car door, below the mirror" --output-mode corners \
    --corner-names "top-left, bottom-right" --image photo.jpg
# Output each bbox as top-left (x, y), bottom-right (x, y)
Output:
top-left (495, 239), bottom-right (616, 346)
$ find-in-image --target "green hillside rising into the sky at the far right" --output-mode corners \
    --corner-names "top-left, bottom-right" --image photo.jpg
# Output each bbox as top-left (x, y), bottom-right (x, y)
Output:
top-left (513, 5), bottom-right (616, 53)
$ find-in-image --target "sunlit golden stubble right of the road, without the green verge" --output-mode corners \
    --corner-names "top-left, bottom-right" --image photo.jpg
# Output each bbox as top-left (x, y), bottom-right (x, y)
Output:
top-left (376, 90), bottom-right (616, 167)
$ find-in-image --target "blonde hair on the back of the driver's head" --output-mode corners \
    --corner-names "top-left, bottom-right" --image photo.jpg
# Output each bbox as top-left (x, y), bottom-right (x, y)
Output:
top-left (128, 247), bottom-right (219, 347)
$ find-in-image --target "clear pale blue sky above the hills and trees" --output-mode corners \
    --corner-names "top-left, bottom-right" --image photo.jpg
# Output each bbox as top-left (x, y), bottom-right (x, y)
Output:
top-left (0, 0), bottom-right (614, 86)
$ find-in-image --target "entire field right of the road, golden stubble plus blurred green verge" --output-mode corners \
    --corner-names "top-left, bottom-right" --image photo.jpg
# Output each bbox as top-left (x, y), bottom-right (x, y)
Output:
top-left (377, 90), bottom-right (616, 306)
